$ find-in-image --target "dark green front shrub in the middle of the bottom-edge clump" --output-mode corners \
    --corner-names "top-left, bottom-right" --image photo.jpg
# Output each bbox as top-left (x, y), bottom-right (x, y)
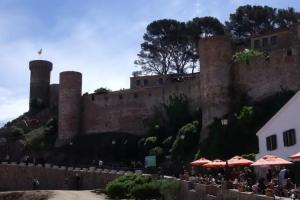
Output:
top-left (130, 181), bottom-right (161, 199)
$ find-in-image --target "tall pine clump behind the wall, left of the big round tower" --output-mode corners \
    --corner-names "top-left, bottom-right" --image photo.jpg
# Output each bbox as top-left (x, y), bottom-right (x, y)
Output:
top-left (135, 17), bottom-right (224, 75)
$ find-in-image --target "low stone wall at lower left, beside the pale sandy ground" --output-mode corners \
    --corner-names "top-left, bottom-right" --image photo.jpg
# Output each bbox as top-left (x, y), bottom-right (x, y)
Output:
top-left (0, 163), bottom-right (125, 191)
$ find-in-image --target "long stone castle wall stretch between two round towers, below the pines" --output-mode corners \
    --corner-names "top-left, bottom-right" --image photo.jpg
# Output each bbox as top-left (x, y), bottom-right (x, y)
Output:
top-left (82, 79), bottom-right (201, 135)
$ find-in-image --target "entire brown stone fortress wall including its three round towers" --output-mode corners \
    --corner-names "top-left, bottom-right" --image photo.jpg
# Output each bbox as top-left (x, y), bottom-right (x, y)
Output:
top-left (30, 25), bottom-right (300, 144)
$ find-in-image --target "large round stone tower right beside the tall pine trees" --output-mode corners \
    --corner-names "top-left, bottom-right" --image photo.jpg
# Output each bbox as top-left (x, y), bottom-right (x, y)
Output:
top-left (199, 36), bottom-right (232, 140)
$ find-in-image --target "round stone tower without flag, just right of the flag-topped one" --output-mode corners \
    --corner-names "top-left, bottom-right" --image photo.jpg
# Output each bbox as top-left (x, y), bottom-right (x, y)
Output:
top-left (56, 71), bottom-right (82, 146)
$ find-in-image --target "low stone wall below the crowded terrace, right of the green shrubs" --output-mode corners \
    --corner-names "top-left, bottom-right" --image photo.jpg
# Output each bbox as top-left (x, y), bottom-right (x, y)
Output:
top-left (179, 181), bottom-right (274, 200)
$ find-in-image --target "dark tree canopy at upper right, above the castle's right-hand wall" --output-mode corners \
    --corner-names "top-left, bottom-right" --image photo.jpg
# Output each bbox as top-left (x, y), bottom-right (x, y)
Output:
top-left (225, 5), bottom-right (300, 40)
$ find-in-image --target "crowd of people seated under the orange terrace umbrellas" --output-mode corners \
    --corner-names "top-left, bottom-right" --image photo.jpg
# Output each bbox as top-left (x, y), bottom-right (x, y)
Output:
top-left (180, 167), bottom-right (300, 199)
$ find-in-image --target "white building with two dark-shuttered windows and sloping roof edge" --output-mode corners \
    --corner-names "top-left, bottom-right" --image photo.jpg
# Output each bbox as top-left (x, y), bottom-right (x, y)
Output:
top-left (256, 91), bottom-right (300, 159)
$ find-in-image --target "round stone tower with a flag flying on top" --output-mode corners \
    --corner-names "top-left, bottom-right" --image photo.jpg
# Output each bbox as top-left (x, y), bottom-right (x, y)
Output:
top-left (29, 60), bottom-right (52, 110)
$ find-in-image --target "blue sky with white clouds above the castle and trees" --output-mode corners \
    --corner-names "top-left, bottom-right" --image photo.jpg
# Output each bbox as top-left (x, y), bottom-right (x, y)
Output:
top-left (0, 0), bottom-right (300, 125)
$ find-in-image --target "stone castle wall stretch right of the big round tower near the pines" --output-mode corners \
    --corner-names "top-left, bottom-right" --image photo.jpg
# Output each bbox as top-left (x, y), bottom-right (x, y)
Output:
top-left (233, 47), bottom-right (300, 101)
